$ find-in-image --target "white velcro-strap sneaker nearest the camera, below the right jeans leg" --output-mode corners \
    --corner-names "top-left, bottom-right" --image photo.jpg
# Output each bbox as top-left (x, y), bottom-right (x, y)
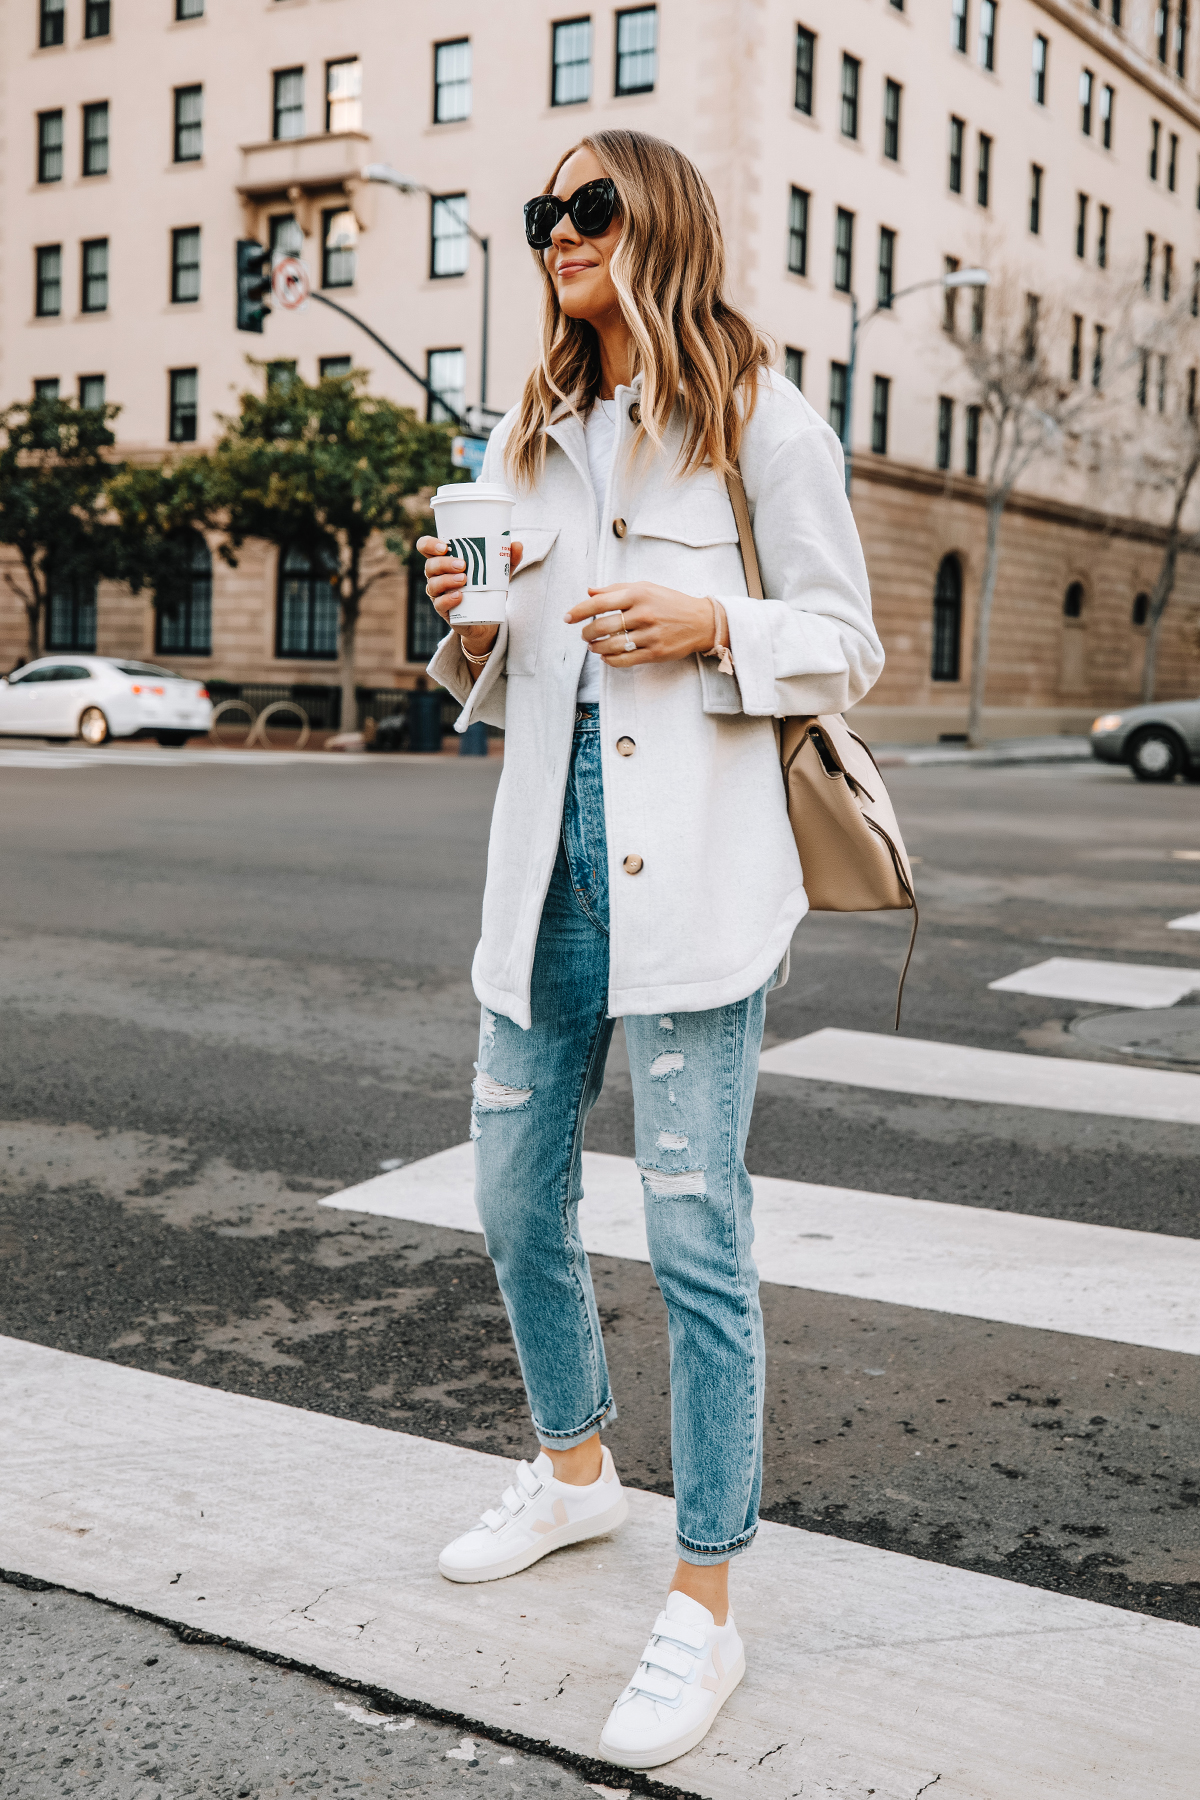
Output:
top-left (599, 1593), bottom-right (747, 1769)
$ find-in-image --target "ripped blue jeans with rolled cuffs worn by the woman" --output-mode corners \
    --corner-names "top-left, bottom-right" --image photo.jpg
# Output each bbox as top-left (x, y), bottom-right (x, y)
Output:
top-left (471, 706), bottom-right (770, 1562)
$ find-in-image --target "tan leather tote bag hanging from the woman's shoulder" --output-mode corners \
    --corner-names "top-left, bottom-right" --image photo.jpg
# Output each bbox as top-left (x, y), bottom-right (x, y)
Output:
top-left (729, 473), bottom-right (919, 1030)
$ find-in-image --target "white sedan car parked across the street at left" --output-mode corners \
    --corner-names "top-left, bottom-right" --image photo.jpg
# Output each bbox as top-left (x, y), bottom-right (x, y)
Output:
top-left (0, 652), bottom-right (212, 747)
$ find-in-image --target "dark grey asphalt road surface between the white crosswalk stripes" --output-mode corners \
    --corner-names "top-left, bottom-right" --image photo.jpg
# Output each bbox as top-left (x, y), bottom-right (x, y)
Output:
top-left (0, 752), bottom-right (1200, 1800)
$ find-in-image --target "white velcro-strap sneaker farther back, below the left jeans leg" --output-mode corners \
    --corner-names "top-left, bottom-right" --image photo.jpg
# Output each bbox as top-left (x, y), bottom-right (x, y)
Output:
top-left (437, 1449), bottom-right (630, 1580)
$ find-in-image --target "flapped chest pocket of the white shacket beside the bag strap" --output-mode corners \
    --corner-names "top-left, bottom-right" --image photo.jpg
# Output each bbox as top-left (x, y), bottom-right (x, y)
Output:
top-left (624, 473), bottom-right (745, 594)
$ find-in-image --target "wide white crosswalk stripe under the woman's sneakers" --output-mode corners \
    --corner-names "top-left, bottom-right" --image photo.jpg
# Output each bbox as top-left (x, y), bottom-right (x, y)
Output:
top-left (0, 1339), bottom-right (1200, 1800)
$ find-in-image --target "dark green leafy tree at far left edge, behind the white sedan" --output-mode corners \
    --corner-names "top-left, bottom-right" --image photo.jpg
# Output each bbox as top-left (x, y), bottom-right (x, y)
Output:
top-left (0, 400), bottom-right (121, 661)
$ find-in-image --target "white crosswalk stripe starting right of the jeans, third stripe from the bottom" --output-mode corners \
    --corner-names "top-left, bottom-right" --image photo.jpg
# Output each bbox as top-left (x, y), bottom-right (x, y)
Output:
top-left (759, 1026), bottom-right (1200, 1125)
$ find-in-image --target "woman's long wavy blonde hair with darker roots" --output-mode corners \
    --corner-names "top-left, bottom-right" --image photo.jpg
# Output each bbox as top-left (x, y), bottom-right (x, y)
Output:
top-left (506, 131), bottom-right (774, 484)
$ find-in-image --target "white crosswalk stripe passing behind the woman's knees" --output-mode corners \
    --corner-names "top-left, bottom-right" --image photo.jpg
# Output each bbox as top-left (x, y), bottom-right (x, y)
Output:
top-left (320, 1127), bottom-right (1200, 1355)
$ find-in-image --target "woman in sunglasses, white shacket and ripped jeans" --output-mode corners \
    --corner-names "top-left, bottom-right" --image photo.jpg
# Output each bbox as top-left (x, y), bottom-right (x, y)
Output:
top-left (417, 131), bottom-right (883, 1768)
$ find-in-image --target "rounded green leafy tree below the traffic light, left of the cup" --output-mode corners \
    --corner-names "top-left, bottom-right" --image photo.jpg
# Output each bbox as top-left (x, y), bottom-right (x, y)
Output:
top-left (212, 365), bottom-right (453, 729)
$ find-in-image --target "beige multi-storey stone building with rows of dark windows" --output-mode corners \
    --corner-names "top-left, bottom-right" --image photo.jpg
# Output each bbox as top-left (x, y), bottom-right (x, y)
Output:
top-left (0, 0), bottom-right (1200, 736)
